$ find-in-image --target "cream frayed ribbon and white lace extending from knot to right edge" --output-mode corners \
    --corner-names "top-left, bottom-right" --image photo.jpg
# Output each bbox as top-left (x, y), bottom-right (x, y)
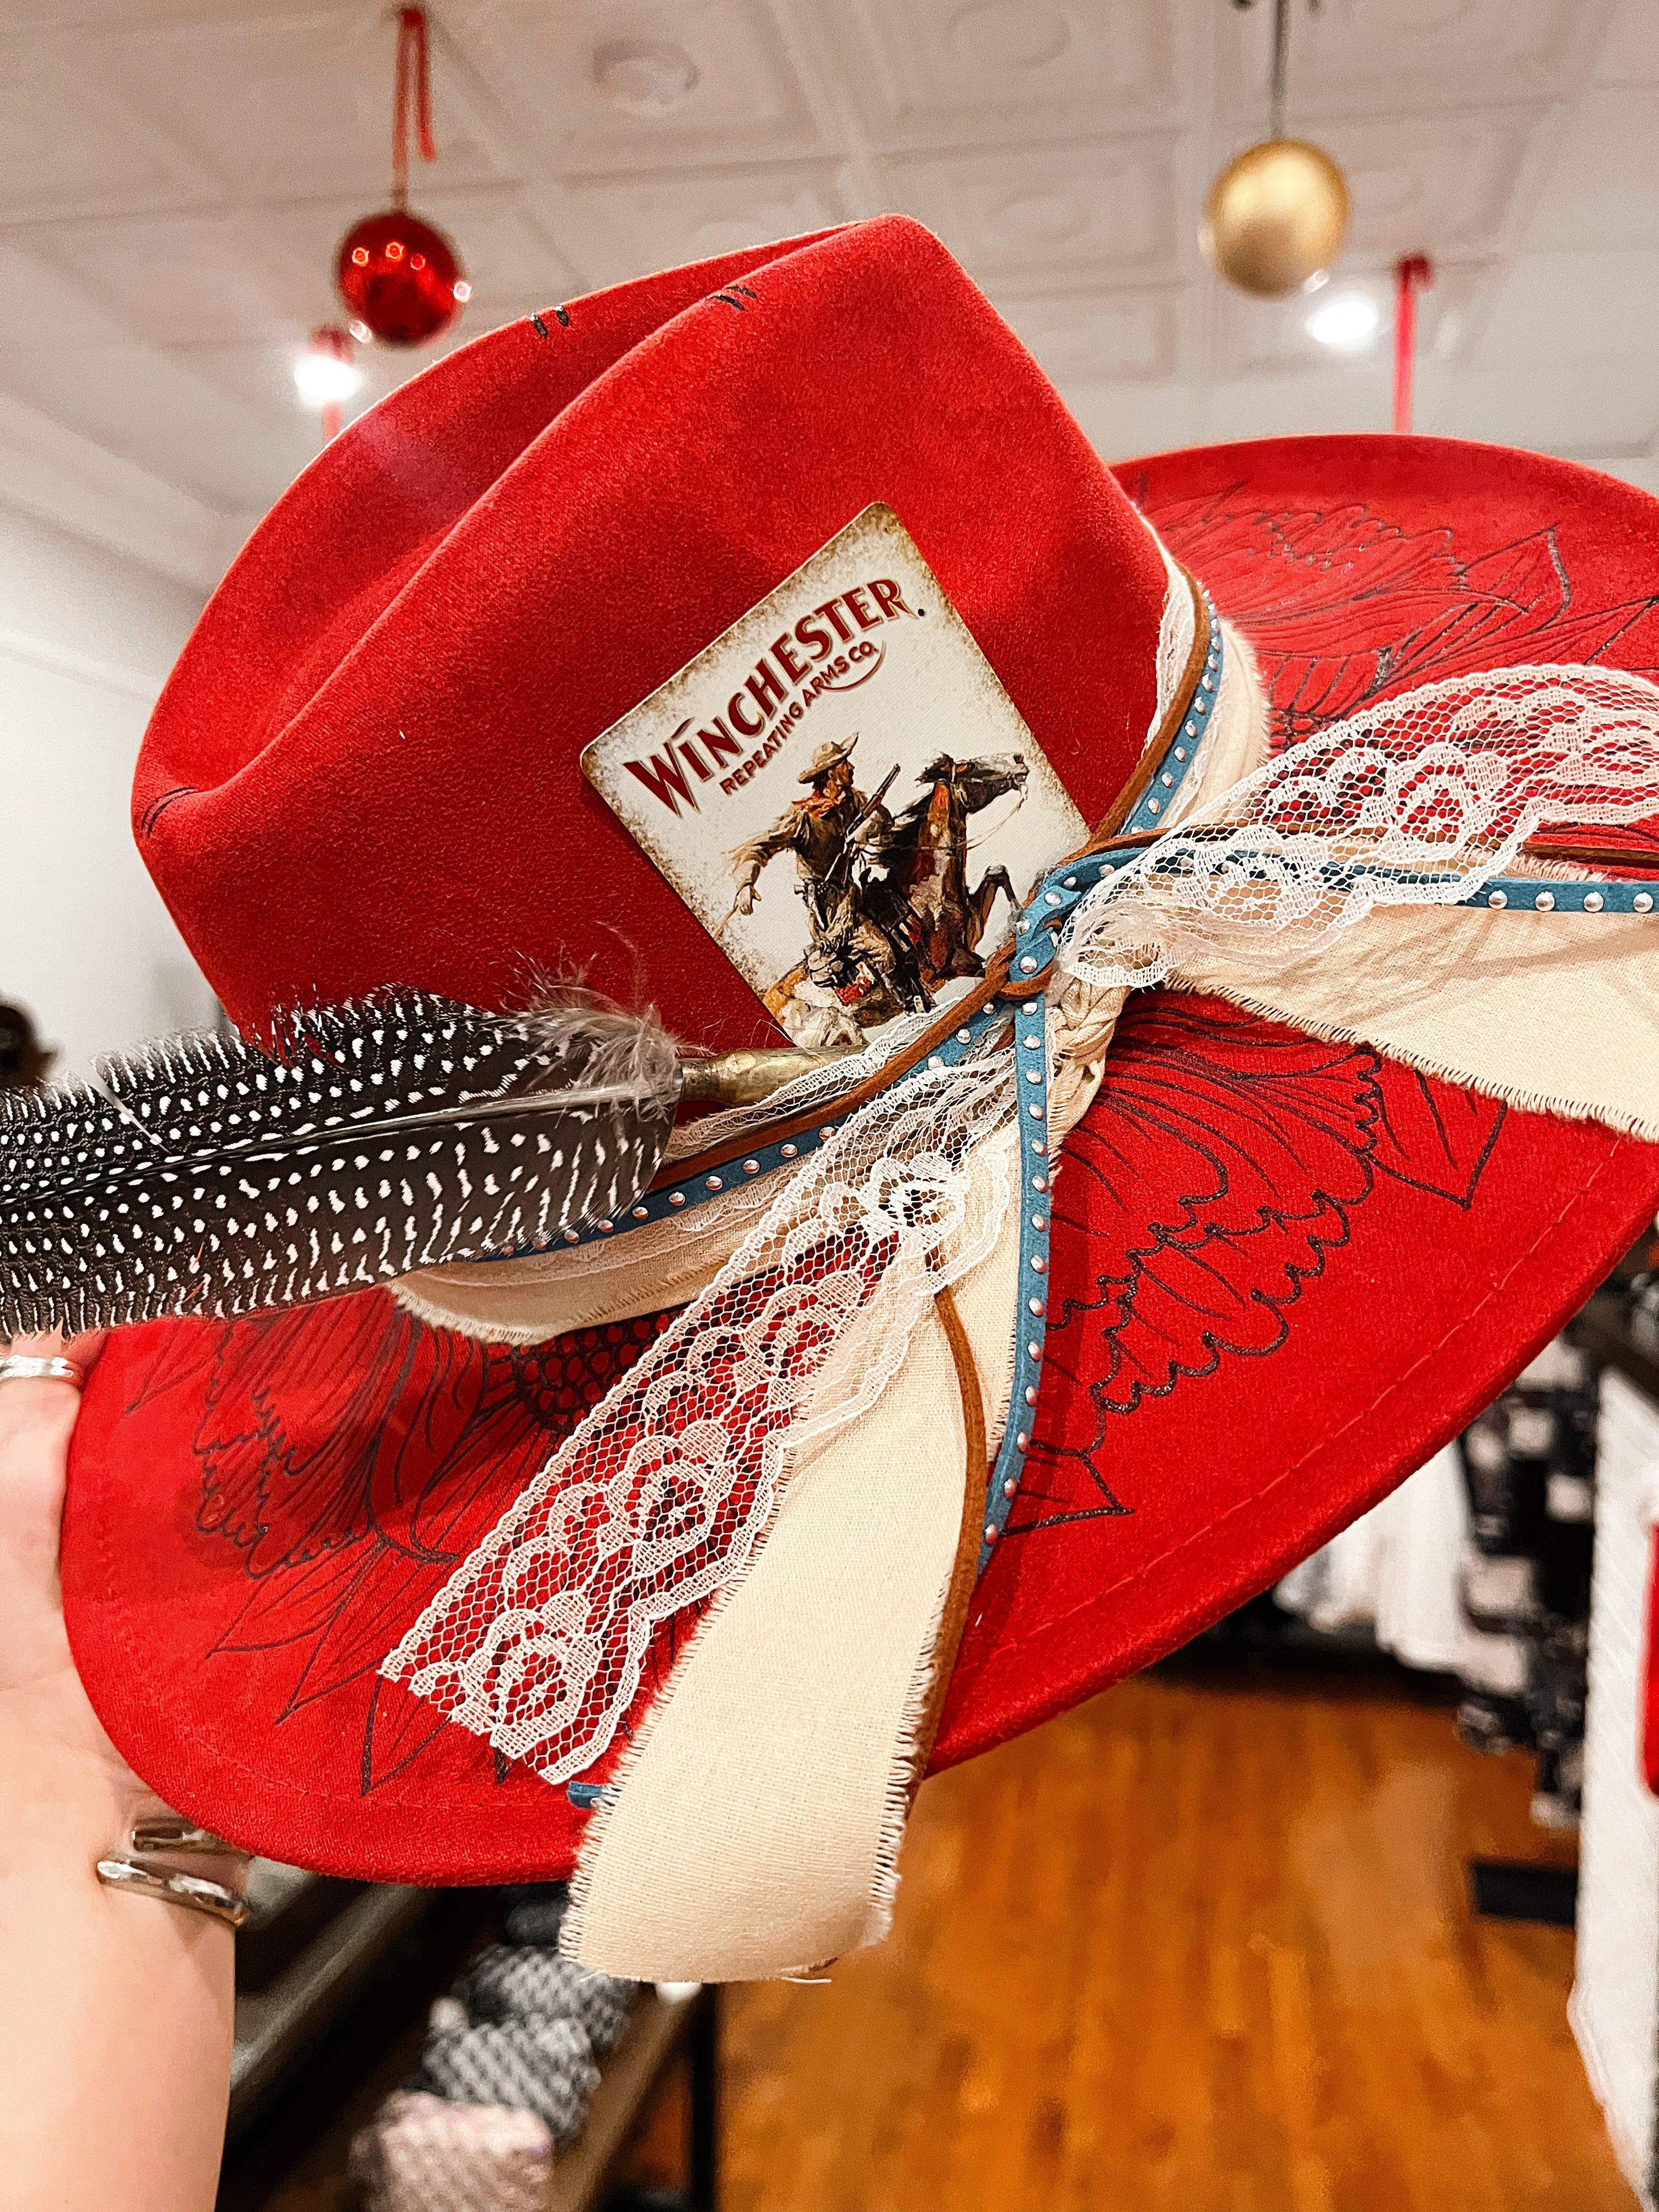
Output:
top-left (1059, 666), bottom-right (1659, 1139)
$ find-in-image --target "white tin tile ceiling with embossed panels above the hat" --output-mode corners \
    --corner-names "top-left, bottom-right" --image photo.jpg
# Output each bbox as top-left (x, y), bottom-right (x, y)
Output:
top-left (0, 0), bottom-right (1659, 517)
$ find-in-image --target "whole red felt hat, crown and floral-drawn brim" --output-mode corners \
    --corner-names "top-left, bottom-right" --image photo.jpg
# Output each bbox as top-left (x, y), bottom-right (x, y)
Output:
top-left (62, 219), bottom-right (1659, 1882)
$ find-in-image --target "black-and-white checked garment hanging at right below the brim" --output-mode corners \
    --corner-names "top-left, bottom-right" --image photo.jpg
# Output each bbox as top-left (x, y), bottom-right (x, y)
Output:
top-left (1458, 1336), bottom-right (1599, 1827)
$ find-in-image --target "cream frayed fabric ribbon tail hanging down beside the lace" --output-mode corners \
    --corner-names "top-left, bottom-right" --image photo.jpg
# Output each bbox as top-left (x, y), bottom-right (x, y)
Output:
top-left (562, 1130), bottom-right (1020, 1982)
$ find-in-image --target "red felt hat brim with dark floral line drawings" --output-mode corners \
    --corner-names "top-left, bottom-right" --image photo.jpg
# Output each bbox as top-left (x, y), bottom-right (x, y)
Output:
top-left (64, 438), bottom-right (1659, 1882)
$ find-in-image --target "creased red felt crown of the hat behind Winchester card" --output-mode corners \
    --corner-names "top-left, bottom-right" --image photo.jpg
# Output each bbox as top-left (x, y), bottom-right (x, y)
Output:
top-left (133, 217), bottom-right (1166, 1048)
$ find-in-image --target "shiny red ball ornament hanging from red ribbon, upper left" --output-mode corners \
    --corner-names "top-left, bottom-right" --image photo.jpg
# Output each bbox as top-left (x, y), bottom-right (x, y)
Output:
top-left (334, 7), bottom-right (471, 345)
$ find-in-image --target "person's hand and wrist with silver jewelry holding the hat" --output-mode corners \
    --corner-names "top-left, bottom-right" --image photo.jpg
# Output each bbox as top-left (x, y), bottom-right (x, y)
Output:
top-left (0, 1336), bottom-right (239, 2212)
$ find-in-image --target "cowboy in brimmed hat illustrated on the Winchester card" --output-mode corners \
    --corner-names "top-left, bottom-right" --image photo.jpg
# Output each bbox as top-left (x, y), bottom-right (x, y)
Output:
top-left (732, 732), bottom-right (934, 1011)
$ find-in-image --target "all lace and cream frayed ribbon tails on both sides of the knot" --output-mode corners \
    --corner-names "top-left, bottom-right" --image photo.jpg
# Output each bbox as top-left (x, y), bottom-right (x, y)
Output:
top-left (387, 646), bottom-right (1659, 1980)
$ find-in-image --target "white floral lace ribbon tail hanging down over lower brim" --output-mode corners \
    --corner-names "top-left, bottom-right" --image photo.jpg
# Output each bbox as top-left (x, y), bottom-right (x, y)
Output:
top-left (383, 1055), bottom-right (1013, 1783)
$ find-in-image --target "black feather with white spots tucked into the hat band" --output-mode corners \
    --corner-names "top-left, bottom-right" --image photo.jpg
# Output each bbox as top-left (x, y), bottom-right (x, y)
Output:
top-left (0, 993), bottom-right (681, 1338)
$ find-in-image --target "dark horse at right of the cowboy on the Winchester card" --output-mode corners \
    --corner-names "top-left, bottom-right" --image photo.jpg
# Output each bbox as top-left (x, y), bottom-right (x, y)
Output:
top-left (881, 752), bottom-right (1031, 986)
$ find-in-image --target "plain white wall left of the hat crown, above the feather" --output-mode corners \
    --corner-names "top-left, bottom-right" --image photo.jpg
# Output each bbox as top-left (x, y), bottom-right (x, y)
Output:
top-left (0, 504), bottom-right (212, 1075)
